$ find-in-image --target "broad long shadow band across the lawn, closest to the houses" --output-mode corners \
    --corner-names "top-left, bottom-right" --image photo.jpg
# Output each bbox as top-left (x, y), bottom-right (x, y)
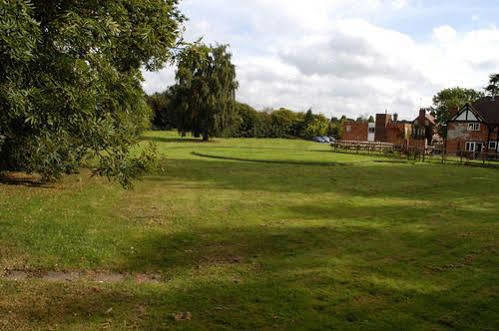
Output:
top-left (145, 158), bottom-right (499, 205)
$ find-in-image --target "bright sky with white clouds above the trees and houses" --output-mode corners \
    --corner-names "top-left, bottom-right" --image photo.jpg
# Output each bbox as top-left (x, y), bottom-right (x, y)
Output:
top-left (143, 0), bottom-right (499, 119)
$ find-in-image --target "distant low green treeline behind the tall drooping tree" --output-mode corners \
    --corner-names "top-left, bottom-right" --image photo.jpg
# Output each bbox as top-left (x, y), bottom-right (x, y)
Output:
top-left (147, 91), bottom-right (368, 139)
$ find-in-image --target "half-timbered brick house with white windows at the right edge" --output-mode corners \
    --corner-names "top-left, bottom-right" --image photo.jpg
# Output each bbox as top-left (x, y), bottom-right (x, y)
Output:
top-left (447, 97), bottom-right (499, 154)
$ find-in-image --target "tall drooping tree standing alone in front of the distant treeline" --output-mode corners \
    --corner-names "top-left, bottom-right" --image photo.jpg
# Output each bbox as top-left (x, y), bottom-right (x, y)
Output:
top-left (174, 44), bottom-right (238, 141)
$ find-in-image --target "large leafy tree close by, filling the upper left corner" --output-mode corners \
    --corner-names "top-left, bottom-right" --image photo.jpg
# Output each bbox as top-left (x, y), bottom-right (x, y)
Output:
top-left (0, 0), bottom-right (184, 186)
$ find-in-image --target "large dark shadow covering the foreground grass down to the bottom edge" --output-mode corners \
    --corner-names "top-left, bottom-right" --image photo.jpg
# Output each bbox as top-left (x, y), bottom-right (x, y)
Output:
top-left (0, 219), bottom-right (498, 330)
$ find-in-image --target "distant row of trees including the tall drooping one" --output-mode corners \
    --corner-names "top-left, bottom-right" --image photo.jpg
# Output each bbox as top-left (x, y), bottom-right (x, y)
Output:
top-left (148, 43), bottom-right (340, 140)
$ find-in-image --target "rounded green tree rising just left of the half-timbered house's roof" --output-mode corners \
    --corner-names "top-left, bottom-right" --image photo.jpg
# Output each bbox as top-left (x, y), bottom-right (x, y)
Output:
top-left (433, 87), bottom-right (484, 135)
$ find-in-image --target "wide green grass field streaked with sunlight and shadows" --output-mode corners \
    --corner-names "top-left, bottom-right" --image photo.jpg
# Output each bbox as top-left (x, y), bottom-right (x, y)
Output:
top-left (0, 133), bottom-right (499, 330)
